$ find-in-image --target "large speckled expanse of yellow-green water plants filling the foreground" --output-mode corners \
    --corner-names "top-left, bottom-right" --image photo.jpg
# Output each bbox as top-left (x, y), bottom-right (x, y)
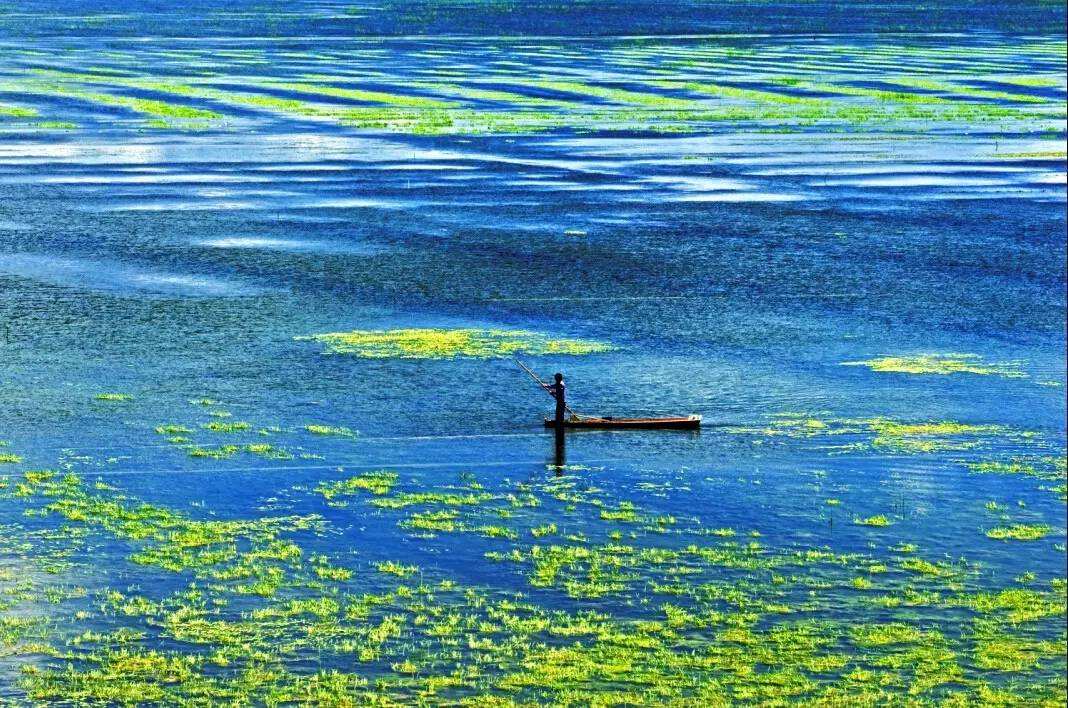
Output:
top-left (0, 401), bottom-right (1066, 706)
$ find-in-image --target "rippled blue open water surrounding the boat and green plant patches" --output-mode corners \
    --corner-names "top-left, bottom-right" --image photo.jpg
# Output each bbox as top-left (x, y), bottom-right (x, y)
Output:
top-left (0, 1), bottom-right (1066, 701)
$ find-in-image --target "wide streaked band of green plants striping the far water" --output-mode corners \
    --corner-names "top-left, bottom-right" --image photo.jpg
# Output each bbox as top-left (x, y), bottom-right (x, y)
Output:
top-left (18, 40), bottom-right (1065, 135)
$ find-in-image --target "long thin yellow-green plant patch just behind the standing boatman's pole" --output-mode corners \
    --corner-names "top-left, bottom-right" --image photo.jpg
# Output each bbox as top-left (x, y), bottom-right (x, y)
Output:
top-left (296, 329), bottom-right (613, 359)
